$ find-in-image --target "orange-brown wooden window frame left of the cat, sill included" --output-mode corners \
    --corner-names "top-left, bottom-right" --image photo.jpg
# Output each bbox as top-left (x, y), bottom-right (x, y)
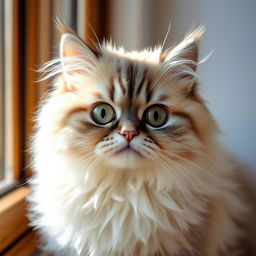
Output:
top-left (0, 0), bottom-right (109, 256)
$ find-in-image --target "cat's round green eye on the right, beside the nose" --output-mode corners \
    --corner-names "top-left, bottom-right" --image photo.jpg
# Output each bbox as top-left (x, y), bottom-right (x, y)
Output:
top-left (144, 105), bottom-right (167, 127)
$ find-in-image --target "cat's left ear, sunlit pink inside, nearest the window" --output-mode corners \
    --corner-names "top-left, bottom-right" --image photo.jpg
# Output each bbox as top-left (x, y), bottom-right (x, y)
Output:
top-left (60, 33), bottom-right (98, 77)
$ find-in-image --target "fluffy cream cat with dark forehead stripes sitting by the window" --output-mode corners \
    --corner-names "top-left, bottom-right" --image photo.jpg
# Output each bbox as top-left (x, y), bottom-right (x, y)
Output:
top-left (29, 27), bottom-right (247, 256)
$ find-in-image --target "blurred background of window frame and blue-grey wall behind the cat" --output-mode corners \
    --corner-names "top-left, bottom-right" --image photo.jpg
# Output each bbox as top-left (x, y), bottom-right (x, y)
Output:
top-left (0, 0), bottom-right (256, 256)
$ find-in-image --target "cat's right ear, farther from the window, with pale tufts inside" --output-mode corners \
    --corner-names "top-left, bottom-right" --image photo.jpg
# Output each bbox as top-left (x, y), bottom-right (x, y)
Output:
top-left (160, 27), bottom-right (205, 71)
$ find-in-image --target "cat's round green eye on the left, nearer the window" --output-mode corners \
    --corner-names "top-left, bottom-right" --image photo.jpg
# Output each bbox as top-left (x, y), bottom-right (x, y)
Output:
top-left (91, 103), bottom-right (115, 125)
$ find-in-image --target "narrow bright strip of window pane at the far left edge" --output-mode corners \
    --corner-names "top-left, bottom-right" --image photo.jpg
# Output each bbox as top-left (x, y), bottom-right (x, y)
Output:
top-left (0, 1), bottom-right (19, 193)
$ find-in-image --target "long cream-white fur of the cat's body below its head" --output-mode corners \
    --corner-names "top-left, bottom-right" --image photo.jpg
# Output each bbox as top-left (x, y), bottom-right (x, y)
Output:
top-left (30, 131), bottom-right (244, 256)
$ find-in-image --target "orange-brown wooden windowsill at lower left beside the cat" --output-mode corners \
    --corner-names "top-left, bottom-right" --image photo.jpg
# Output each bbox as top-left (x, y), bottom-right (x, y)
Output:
top-left (0, 186), bottom-right (34, 254)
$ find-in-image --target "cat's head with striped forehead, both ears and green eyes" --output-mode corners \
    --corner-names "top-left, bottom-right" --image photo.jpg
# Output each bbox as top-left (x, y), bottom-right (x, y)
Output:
top-left (39, 29), bottom-right (218, 169)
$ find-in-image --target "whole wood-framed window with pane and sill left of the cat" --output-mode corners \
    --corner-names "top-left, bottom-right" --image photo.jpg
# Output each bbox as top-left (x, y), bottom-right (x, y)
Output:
top-left (0, 0), bottom-right (107, 256)
